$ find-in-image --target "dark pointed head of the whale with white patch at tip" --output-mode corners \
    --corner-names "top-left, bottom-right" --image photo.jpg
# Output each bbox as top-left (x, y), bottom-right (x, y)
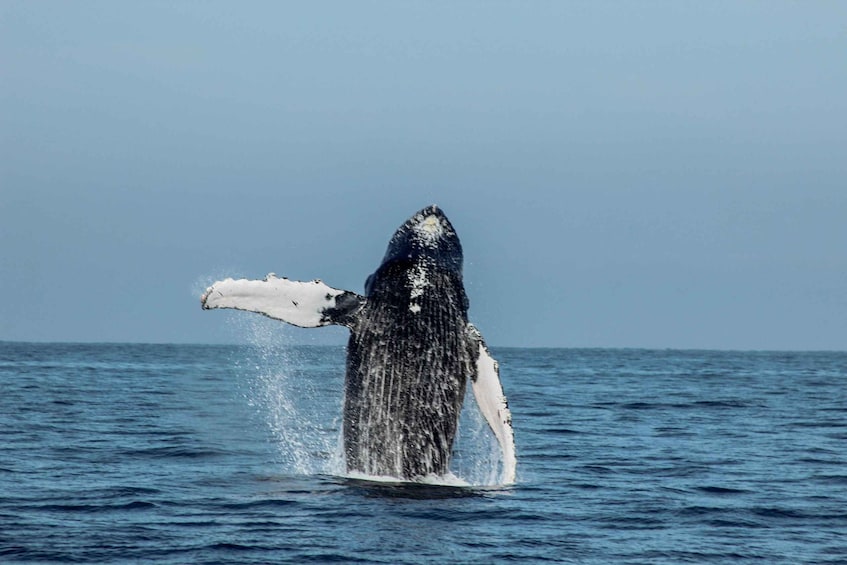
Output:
top-left (365, 205), bottom-right (463, 295)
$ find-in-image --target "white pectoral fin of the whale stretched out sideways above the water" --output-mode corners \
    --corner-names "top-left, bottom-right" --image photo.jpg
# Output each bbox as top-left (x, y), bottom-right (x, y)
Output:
top-left (205, 273), bottom-right (365, 328)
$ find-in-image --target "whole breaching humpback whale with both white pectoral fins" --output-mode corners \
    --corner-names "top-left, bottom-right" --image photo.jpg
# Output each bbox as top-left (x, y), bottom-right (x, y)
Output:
top-left (201, 206), bottom-right (516, 484)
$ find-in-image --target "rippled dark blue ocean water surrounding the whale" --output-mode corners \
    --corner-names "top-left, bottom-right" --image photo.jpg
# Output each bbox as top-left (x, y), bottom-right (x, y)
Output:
top-left (0, 343), bottom-right (847, 564)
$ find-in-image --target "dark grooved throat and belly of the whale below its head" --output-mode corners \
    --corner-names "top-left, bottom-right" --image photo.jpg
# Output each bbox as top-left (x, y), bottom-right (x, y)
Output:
top-left (344, 270), bottom-right (476, 478)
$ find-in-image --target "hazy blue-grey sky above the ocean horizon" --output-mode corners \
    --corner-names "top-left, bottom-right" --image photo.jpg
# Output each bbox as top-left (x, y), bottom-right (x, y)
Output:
top-left (0, 0), bottom-right (847, 350)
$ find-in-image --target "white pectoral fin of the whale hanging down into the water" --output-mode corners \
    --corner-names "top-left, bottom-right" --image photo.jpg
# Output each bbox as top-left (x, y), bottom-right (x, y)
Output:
top-left (468, 324), bottom-right (517, 485)
